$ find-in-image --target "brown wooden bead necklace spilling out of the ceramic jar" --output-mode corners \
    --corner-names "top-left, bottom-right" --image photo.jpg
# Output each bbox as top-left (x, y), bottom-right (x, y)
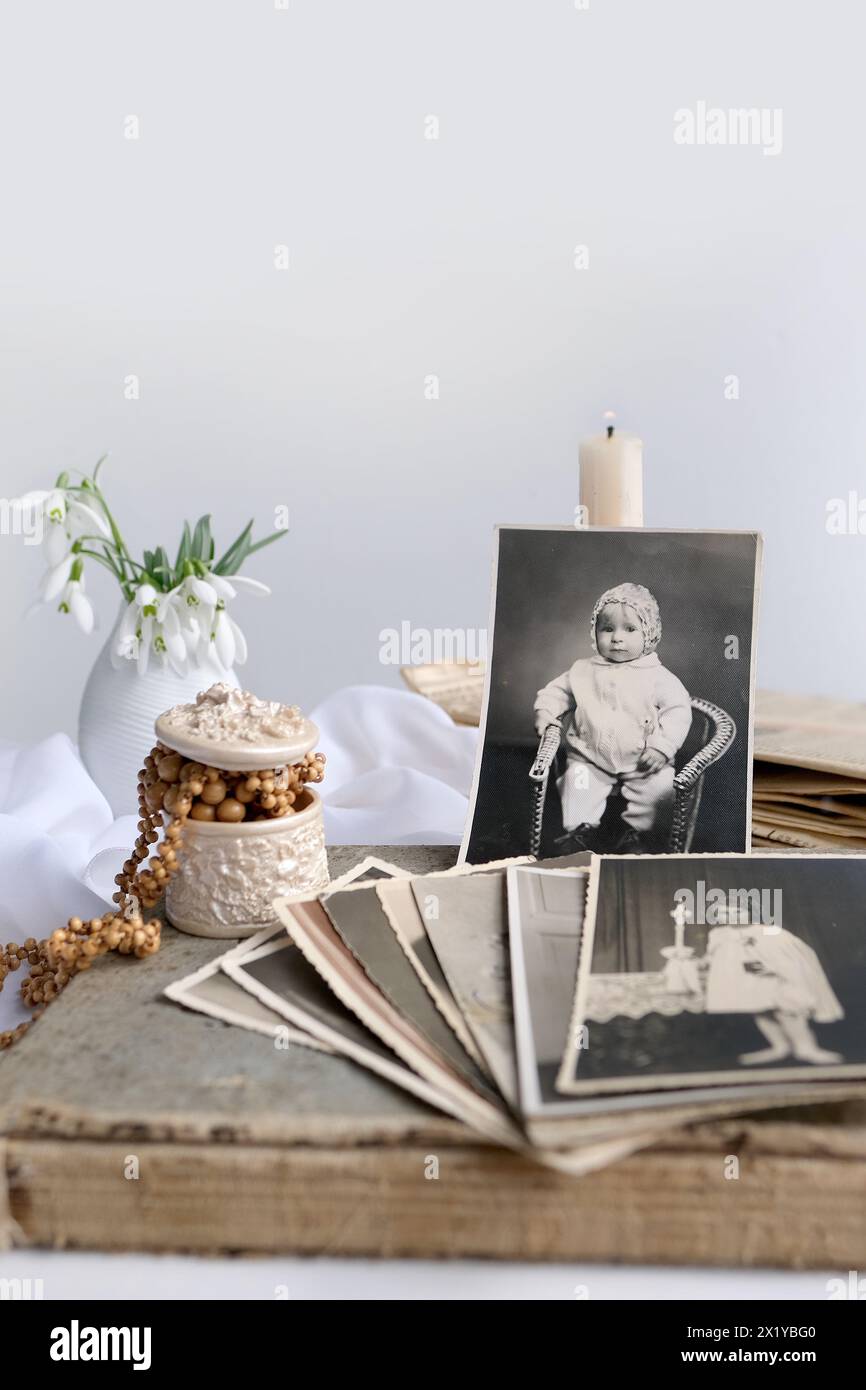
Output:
top-left (0, 744), bottom-right (325, 1049)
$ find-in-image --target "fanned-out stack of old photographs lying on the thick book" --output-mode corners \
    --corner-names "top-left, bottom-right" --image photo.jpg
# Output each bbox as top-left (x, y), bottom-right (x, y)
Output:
top-left (167, 852), bottom-right (866, 1173)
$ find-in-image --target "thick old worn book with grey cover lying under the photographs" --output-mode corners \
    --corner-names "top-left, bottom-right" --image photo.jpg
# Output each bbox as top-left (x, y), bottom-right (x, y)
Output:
top-left (0, 847), bottom-right (866, 1269)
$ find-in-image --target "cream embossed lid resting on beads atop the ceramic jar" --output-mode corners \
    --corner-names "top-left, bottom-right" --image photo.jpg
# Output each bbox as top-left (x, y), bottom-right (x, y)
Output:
top-left (154, 685), bottom-right (318, 771)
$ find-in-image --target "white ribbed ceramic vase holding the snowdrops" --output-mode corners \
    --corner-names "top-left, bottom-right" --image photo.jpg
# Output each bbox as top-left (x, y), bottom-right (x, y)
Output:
top-left (78, 603), bottom-right (239, 816)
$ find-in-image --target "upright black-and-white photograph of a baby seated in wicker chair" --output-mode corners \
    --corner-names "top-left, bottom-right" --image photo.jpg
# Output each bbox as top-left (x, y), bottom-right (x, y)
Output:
top-left (460, 525), bottom-right (762, 863)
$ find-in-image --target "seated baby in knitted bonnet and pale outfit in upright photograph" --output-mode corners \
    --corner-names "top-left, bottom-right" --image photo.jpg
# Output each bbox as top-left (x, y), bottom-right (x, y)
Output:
top-left (535, 584), bottom-right (692, 848)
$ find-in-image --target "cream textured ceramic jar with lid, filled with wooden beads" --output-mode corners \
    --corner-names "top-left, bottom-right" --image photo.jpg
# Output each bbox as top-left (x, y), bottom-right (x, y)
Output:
top-left (156, 685), bottom-right (329, 938)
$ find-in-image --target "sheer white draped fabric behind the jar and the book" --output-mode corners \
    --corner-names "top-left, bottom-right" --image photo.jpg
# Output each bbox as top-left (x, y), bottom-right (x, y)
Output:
top-left (0, 685), bottom-right (478, 1027)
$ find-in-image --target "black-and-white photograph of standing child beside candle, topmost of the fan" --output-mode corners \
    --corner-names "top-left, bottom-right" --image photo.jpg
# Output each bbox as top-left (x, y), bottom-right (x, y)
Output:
top-left (557, 853), bottom-right (866, 1094)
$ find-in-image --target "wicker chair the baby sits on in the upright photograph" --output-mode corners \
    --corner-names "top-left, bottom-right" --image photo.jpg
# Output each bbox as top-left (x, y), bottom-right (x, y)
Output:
top-left (530, 699), bottom-right (737, 855)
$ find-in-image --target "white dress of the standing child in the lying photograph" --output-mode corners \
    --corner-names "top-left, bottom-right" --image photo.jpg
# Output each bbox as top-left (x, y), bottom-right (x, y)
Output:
top-left (706, 926), bottom-right (844, 1023)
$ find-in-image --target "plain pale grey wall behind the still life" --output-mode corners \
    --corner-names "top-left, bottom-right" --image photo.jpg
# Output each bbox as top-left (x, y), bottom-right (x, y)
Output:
top-left (0, 0), bottom-right (866, 739)
